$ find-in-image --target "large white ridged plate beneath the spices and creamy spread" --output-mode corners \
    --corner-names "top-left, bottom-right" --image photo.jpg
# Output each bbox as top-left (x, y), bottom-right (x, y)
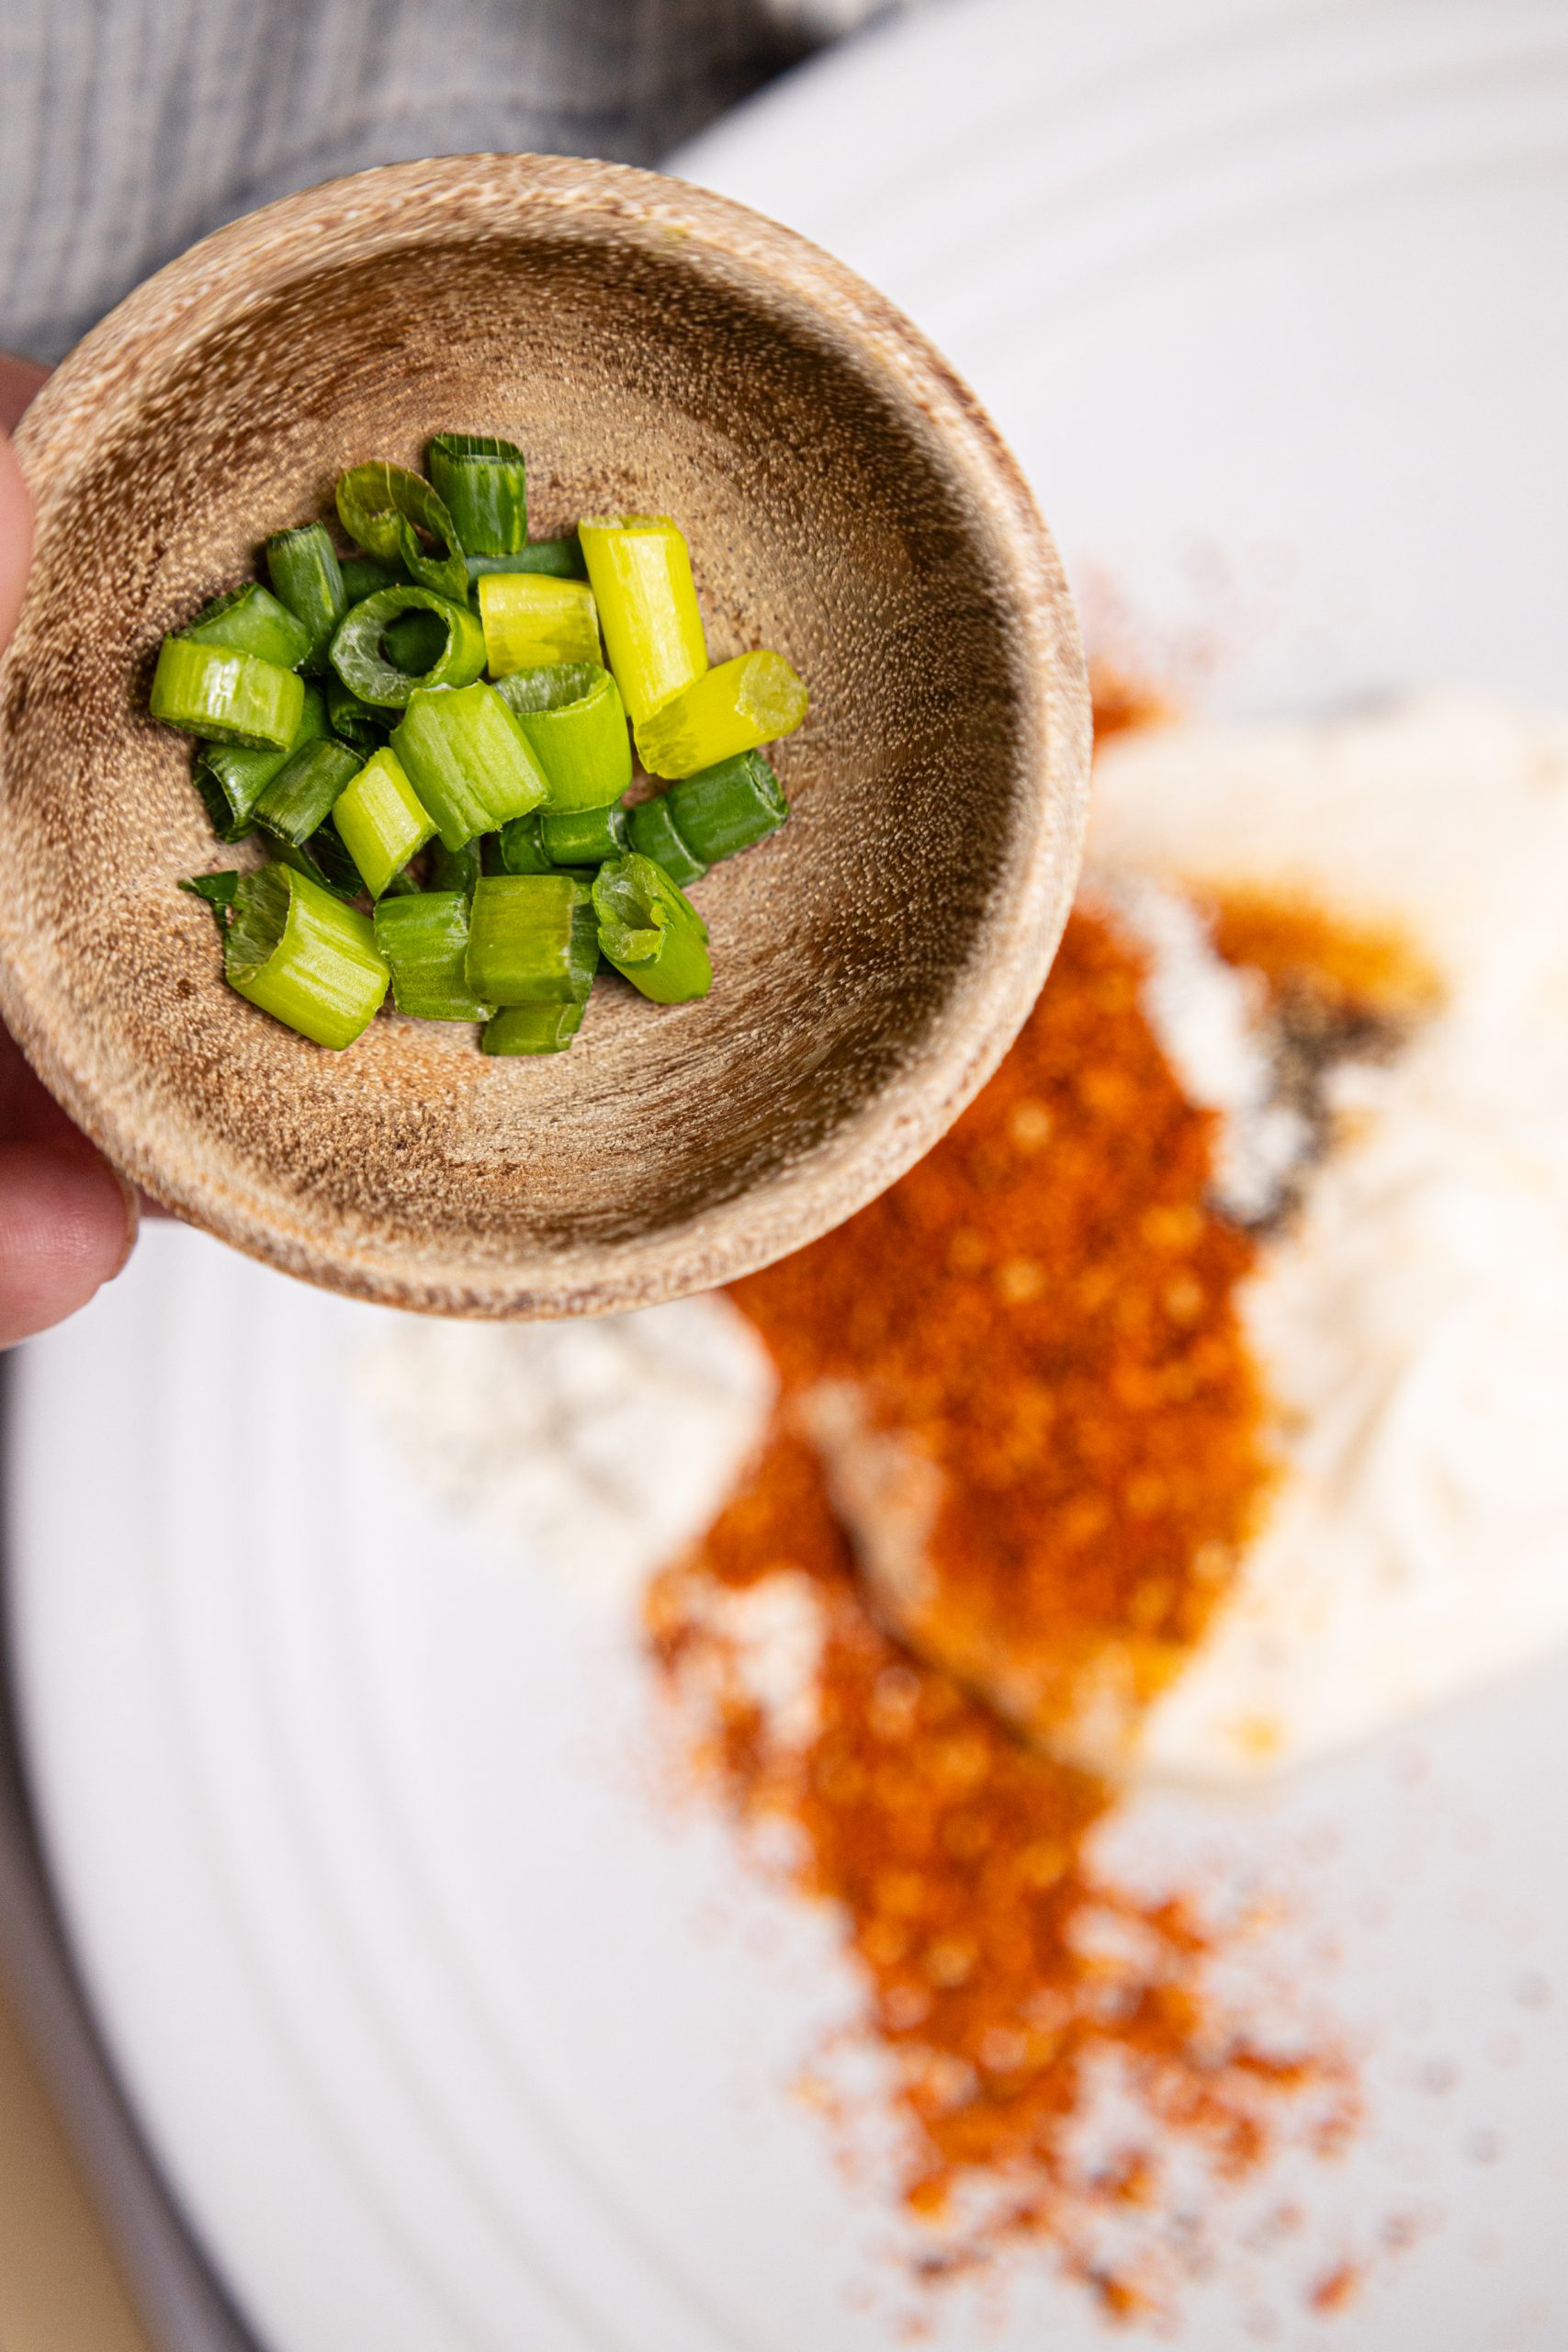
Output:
top-left (9, 0), bottom-right (1568, 2352)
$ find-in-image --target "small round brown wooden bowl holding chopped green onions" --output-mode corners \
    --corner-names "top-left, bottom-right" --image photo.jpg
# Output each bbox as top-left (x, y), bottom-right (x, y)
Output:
top-left (0, 155), bottom-right (1089, 1315)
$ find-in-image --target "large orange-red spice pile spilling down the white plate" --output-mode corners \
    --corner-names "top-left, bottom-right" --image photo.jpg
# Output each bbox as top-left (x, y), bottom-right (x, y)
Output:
top-left (651, 912), bottom-right (1349, 2310)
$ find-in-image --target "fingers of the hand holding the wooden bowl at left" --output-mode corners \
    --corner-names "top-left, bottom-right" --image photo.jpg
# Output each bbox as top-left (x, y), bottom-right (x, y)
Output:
top-left (0, 356), bottom-right (136, 1348)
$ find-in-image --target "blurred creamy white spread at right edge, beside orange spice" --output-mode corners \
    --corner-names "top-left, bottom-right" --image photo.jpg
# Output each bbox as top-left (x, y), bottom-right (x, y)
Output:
top-left (1090, 696), bottom-right (1568, 1778)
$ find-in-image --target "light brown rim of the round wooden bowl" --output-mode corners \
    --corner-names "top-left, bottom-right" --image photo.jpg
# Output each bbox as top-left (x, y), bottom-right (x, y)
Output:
top-left (0, 155), bottom-right (1090, 1317)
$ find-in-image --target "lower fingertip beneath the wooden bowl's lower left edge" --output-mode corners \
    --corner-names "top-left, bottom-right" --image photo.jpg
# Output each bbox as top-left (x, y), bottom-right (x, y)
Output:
top-left (0, 1143), bottom-right (136, 1348)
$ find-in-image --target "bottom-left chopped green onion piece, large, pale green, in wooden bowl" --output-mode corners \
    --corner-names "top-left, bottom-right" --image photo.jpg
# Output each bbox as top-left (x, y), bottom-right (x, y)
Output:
top-left (223, 865), bottom-right (388, 1049)
